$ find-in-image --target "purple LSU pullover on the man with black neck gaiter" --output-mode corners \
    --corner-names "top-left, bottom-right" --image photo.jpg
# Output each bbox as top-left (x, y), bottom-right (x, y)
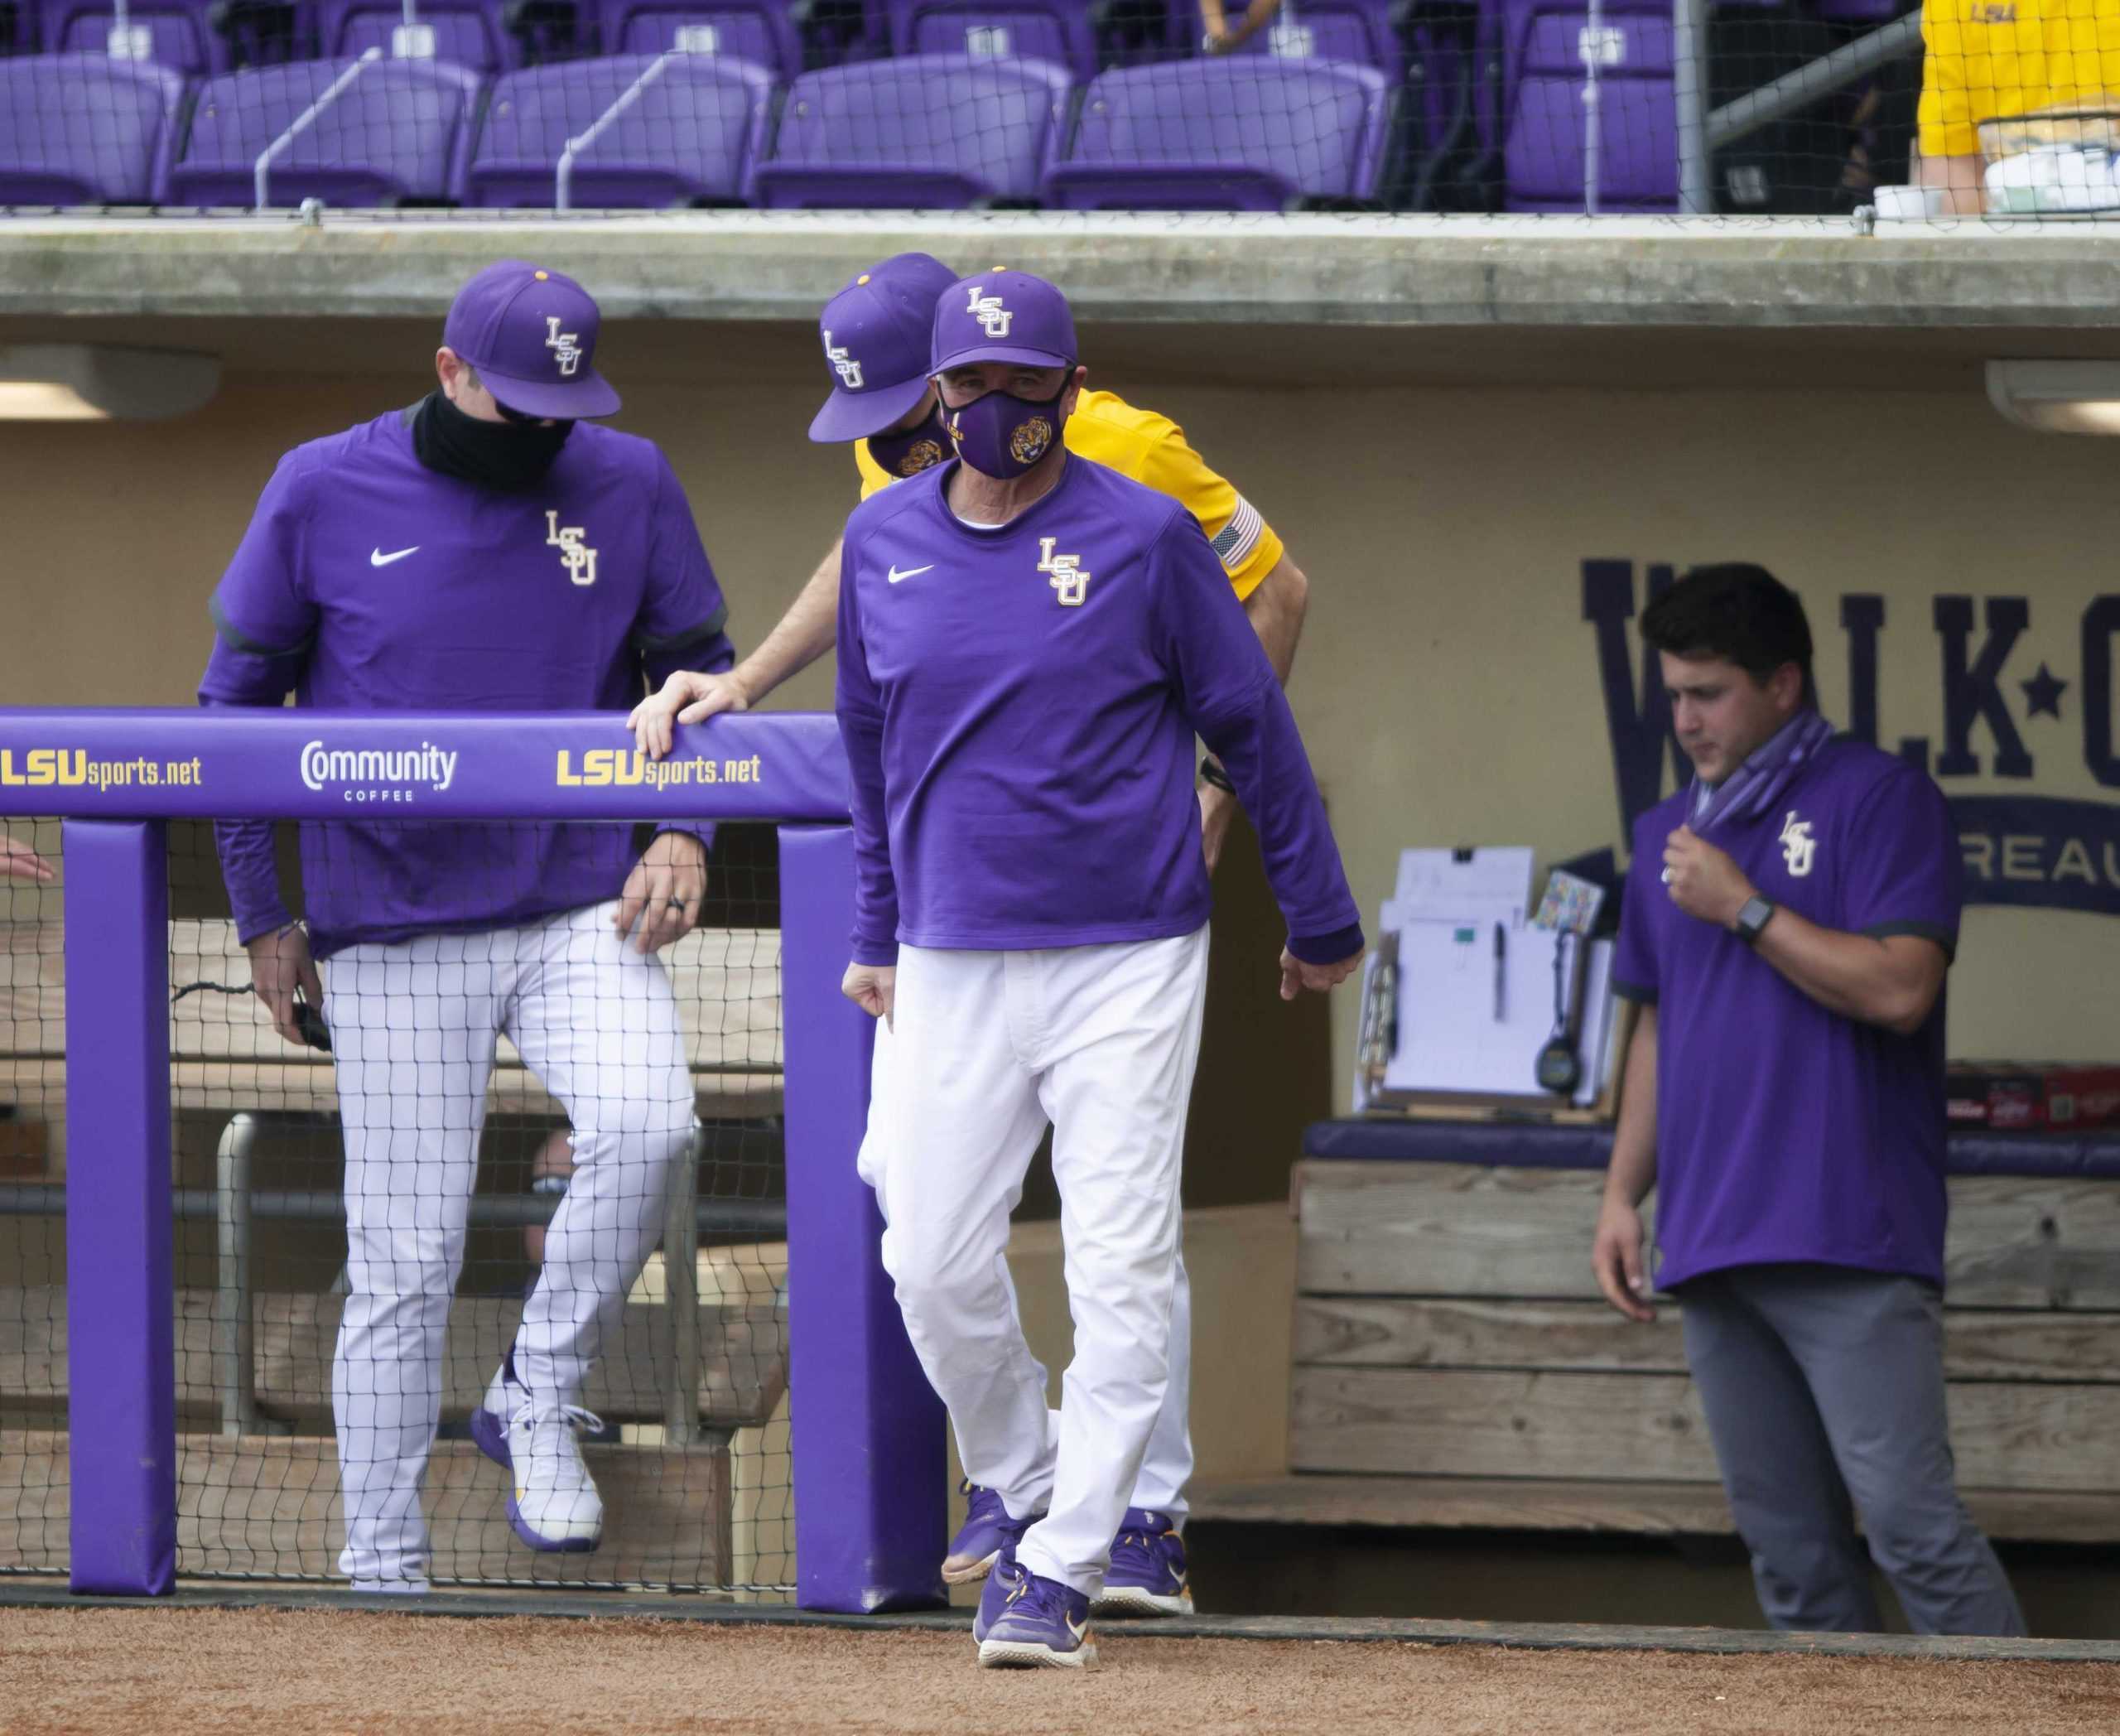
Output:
top-left (200, 411), bottom-right (734, 956)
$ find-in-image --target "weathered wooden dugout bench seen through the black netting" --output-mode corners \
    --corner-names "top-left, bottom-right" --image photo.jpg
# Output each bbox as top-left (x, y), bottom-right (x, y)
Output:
top-left (0, 918), bottom-right (787, 1581)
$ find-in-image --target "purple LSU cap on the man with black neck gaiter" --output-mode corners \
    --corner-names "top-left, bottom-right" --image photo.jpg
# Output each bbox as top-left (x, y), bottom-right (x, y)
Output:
top-left (441, 258), bottom-right (619, 422)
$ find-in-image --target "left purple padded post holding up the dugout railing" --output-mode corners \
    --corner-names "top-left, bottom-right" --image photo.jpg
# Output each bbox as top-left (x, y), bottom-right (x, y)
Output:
top-left (64, 820), bottom-right (176, 1596)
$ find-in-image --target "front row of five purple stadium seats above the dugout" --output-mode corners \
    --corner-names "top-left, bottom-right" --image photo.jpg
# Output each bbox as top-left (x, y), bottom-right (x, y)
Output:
top-left (0, 53), bottom-right (1424, 210)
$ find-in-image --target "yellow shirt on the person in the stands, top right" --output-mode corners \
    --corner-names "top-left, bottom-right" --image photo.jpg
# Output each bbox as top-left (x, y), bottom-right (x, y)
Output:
top-left (1920, 0), bottom-right (2120, 157)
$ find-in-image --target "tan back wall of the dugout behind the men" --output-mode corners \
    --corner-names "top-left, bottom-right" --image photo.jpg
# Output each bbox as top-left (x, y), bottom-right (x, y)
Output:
top-left (0, 322), bottom-right (2120, 1102)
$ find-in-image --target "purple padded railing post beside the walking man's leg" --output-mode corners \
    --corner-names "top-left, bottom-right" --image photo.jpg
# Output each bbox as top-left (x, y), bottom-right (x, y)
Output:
top-left (780, 827), bottom-right (947, 1611)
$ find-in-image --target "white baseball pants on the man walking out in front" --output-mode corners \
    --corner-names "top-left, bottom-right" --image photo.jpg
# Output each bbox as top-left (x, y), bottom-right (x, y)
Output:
top-left (863, 928), bottom-right (1207, 1596)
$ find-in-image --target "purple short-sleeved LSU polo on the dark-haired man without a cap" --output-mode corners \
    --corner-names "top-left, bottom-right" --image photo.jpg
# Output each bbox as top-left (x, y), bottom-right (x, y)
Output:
top-left (1613, 738), bottom-right (1961, 1289)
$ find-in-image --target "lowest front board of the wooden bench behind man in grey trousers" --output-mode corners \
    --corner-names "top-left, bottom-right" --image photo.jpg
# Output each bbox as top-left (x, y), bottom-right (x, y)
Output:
top-left (1289, 1367), bottom-right (2120, 1492)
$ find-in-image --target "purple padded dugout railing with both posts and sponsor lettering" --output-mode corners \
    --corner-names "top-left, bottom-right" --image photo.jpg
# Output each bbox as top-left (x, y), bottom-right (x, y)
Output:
top-left (0, 710), bottom-right (947, 1611)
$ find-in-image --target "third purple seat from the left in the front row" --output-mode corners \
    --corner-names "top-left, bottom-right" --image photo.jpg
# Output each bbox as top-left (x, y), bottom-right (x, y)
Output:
top-left (465, 53), bottom-right (773, 208)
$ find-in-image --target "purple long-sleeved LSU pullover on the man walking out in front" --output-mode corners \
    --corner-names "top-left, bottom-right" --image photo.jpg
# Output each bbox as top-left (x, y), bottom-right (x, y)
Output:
top-left (837, 456), bottom-right (1361, 964)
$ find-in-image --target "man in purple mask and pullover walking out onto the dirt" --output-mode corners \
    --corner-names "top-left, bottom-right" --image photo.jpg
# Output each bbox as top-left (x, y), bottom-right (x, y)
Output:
top-left (837, 272), bottom-right (1361, 1666)
